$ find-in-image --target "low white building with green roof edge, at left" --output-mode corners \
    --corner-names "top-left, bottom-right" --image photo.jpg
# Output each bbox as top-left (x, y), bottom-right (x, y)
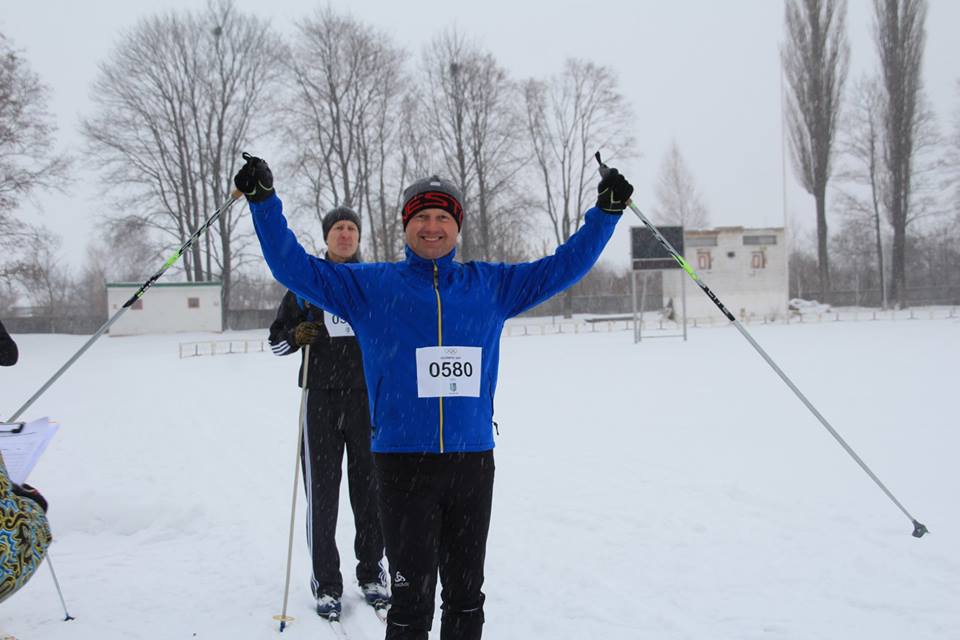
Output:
top-left (107, 282), bottom-right (223, 336)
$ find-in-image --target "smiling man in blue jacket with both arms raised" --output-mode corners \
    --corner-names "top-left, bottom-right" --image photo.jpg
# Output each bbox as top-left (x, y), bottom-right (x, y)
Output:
top-left (234, 154), bottom-right (633, 640)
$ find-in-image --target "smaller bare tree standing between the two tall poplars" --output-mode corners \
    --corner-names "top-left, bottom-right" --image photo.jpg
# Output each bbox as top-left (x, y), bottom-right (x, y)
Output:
top-left (838, 77), bottom-right (888, 309)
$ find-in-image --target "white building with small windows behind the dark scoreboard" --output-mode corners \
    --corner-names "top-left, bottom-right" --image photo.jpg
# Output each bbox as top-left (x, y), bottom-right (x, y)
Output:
top-left (663, 227), bottom-right (789, 319)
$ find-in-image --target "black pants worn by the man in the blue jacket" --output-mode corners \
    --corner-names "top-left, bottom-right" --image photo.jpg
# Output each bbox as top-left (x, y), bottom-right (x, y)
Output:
top-left (374, 451), bottom-right (494, 640)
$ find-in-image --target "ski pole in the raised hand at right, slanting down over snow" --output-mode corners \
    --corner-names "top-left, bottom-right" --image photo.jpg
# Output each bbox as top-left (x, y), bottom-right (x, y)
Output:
top-left (595, 151), bottom-right (929, 538)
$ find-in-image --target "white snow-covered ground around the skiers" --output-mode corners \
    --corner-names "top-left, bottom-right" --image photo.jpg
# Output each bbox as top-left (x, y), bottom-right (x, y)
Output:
top-left (0, 318), bottom-right (960, 640)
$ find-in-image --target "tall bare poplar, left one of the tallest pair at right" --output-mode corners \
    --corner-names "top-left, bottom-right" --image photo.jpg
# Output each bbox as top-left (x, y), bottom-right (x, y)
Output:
top-left (782, 0), bottom-right (850, 294)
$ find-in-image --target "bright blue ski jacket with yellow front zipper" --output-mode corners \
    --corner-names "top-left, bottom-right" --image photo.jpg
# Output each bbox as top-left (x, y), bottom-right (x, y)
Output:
top-left (250, 194), bottom-right (620, 453)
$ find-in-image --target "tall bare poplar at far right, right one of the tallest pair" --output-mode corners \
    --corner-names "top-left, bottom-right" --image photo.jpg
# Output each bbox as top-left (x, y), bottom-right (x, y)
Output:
top-left (874, 0), bottom-right (930, 307)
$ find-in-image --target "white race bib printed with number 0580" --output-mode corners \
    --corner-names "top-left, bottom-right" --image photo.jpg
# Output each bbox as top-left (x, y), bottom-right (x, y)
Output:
top-left (417, 347), bottom-right (483, 398)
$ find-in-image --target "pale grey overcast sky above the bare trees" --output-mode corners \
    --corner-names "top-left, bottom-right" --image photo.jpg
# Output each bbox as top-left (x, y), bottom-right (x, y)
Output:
top-left (0, 0), bottom-right (960, 266)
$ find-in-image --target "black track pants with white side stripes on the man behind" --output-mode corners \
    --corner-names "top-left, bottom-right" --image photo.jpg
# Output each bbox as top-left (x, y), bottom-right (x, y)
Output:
top-left (301, 389), bottom-right (383, 597)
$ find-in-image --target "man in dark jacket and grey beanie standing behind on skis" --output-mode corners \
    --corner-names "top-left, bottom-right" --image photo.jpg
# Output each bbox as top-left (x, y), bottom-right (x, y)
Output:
top-left (270, 207), bottom-right (388, 618)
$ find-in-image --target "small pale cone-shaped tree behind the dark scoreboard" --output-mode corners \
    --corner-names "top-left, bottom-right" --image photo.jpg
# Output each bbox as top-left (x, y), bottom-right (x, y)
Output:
top-left (653, 140), bottom-right (710, 229)
